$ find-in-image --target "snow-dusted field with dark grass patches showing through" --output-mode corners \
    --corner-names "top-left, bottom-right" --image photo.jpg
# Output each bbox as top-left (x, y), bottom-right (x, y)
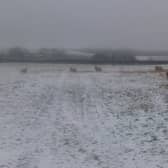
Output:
top-left (0, 64), bottom-right (168, 168)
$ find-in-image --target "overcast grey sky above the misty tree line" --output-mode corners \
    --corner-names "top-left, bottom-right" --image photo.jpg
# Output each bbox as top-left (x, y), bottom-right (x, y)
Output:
top-left (0, 0), bottom-right (168, 49)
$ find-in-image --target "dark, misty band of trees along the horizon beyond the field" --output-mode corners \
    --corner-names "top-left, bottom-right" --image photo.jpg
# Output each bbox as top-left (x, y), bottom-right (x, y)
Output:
top-left (0, 47), bottom-right (167, 64)
